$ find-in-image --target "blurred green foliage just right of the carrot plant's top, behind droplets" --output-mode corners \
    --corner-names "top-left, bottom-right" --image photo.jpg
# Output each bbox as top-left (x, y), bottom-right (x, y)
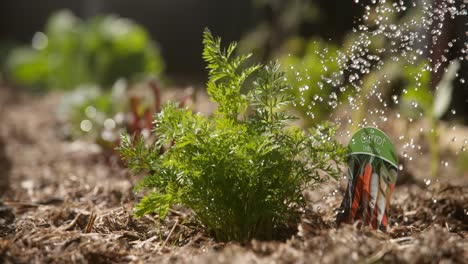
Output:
top-left (279, 38), bottom-right (349, 127)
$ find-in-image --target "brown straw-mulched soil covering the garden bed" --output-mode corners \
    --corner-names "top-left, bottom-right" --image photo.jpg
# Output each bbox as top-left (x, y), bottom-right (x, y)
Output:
top-left (0, 91), bottom-right (468, 263)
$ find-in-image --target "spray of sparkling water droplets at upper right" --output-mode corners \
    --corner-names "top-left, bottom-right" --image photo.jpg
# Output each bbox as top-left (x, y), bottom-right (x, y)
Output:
top-left (288, 0), bottom-right (468, 175)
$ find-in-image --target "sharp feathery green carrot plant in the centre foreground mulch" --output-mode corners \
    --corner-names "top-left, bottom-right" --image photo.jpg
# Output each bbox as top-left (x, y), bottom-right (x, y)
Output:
top-left (119, 30), bottom-right (345, 242)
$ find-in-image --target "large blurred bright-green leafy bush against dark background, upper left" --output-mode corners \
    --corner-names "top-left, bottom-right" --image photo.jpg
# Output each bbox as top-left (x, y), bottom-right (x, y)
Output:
top-left (6, 10), bottom-right (164, 90)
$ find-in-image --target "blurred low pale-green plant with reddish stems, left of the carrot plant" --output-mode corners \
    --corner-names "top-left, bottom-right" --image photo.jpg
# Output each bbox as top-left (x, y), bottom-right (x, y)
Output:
top-left (58, 79), bottom-right (161, 152)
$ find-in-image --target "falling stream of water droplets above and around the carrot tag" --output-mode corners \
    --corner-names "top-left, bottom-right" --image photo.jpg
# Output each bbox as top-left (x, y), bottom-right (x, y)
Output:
top-left (288, 0), bottom-right (468, 215)
